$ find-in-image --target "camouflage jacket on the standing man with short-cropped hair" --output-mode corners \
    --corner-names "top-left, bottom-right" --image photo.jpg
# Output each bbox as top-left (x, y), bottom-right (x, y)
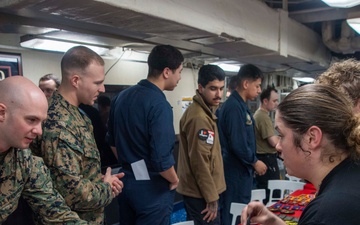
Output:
top-left (34, 93), bottom-right (113, 224)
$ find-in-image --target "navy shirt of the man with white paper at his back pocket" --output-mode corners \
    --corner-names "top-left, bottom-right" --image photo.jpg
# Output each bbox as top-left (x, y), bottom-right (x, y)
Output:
top-left (107, 80), bottom-right (175, 175)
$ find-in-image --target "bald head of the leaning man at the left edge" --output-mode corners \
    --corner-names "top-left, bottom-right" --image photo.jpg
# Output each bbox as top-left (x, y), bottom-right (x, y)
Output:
top-left (0, 76), bottom-right (48, 152)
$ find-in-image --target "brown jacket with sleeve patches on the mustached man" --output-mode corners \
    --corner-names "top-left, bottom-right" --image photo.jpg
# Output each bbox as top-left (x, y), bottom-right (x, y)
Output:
top-left (177, 91), bottom-right (226, 203)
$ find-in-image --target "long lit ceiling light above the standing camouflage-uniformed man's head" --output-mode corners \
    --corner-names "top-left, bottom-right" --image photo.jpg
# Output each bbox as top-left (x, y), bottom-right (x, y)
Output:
top-left (20, 35), bottom-right (109, 55)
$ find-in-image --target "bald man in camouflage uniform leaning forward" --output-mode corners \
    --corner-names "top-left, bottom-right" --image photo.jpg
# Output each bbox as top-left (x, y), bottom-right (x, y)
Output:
top-left (0, 76), bottom-right (87, 224)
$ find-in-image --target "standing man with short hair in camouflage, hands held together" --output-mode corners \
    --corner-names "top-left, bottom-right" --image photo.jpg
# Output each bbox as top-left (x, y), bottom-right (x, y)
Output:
top-left (29, 46), bottom-right (123, 224)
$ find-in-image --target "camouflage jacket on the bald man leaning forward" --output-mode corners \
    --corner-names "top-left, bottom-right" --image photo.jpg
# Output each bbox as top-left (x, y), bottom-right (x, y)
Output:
top-left (0, 148), bottom-right (88, 224)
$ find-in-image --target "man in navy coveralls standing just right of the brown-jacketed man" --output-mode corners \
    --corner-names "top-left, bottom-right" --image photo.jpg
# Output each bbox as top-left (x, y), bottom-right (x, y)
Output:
top-left (218, 64), bottom-right (267, 225)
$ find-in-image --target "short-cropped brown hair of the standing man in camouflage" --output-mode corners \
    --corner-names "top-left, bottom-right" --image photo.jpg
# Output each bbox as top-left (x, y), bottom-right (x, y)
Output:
top-left (61, 46), bottom-right (105, 77)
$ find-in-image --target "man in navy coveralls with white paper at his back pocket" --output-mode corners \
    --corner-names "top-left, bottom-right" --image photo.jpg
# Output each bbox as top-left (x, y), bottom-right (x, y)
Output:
top-left (108, 45), bottom-right (184, 225)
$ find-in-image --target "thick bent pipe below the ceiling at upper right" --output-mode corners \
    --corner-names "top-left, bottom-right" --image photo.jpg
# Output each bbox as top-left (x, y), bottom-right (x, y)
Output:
top-left (322, 20), bottom-right (360, 54)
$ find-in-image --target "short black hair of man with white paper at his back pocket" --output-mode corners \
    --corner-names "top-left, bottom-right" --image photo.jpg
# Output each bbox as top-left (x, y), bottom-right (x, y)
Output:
top-left (148, 45), bottom-right (184, 77)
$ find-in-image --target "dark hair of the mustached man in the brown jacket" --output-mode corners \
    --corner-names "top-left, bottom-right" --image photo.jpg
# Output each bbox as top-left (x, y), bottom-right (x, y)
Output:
top-left (198, 65), bottom-right (225, 87)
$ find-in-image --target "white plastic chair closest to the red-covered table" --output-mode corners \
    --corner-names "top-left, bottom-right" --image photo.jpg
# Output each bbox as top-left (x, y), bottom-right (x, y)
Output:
top-left (266, 180), bottom-right (305, 206)
